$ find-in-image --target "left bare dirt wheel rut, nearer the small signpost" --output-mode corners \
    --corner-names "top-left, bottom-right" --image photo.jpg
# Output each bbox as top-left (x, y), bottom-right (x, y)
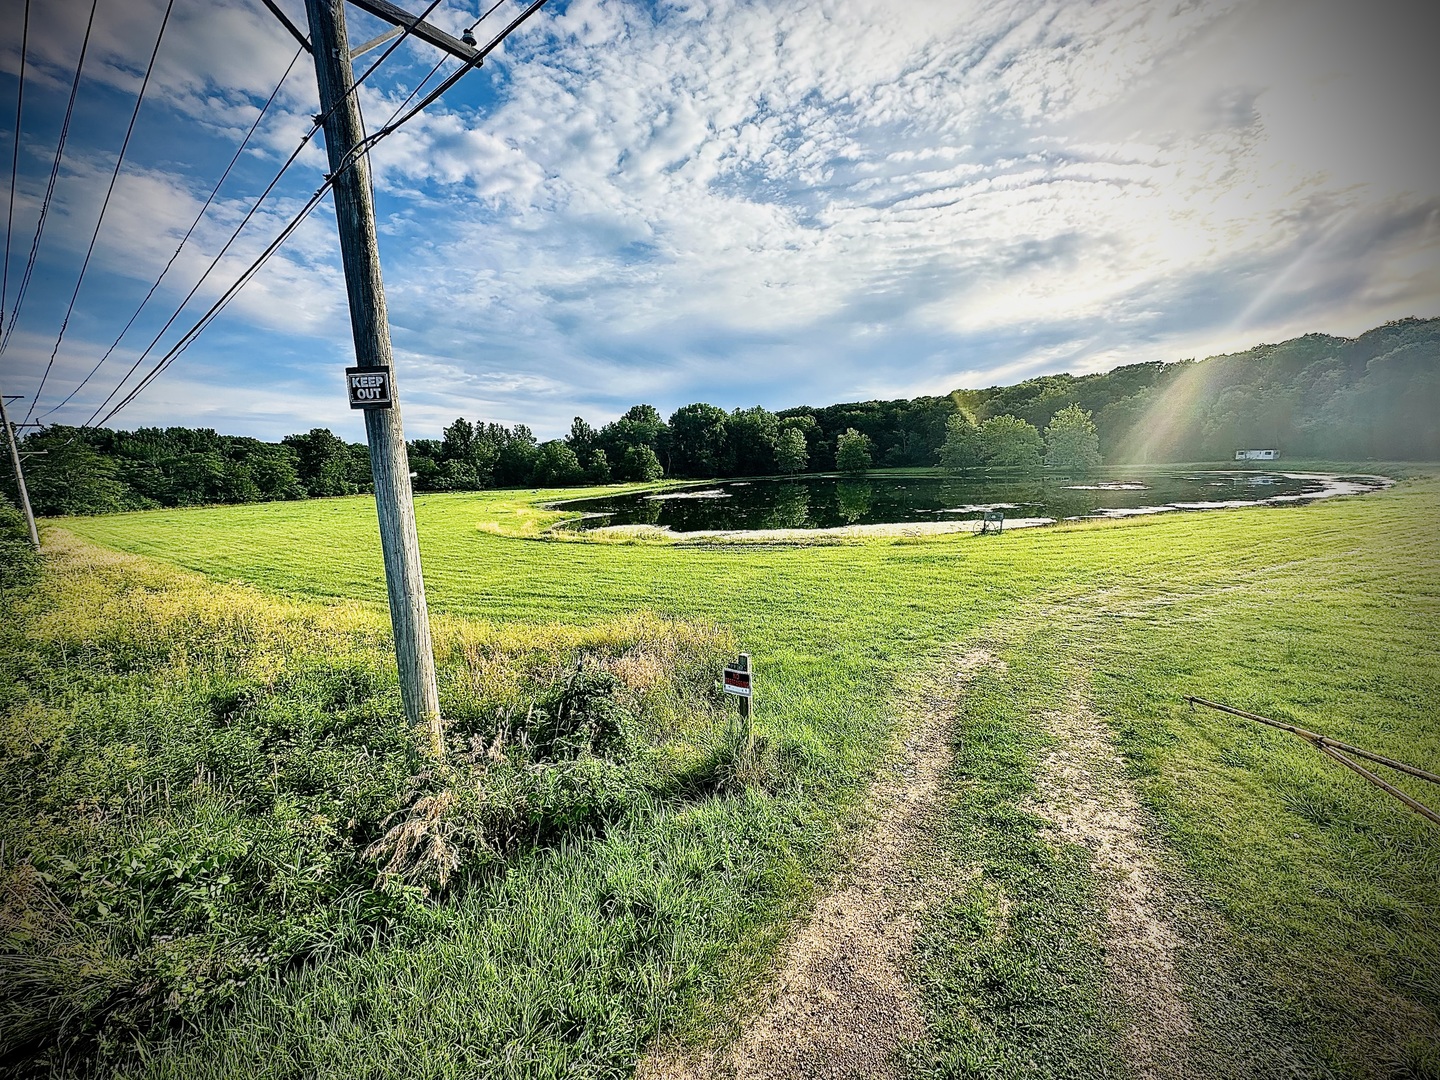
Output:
top-left (636, 649), bottom-right (1002, 1080)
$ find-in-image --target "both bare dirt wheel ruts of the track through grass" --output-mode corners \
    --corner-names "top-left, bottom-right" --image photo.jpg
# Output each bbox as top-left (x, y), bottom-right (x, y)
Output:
top-left (636, 649), bottom-right (1192, 1080)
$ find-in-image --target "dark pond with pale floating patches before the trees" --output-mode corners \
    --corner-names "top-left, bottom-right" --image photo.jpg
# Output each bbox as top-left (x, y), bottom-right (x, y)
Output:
top-left (554, 471), bottom-right (1385, 533)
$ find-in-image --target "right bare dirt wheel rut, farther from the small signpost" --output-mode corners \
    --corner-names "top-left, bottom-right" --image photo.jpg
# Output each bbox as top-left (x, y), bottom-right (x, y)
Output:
top-left (1028, 691), bottom-right (1192, 1079)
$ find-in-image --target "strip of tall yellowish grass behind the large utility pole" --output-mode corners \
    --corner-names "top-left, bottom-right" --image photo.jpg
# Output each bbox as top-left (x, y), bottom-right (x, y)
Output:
top-left (32, 528), bottom-right (734, 731)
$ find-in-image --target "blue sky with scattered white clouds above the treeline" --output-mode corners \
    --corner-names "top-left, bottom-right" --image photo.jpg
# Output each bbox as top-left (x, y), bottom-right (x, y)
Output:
top-left (0, 0), bottom-right (1440, 439)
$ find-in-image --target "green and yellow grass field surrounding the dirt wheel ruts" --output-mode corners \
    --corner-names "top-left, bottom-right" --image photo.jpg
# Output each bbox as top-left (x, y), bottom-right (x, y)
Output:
top-left (0, 471), bottom-right (1440, 1077)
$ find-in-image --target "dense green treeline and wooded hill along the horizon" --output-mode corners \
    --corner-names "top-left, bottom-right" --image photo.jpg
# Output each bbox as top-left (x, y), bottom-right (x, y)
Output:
top-left (4, 318), bottom-right (1440, 514)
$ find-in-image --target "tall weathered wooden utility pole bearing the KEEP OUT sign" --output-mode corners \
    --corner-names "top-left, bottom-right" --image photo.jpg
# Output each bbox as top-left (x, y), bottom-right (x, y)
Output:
top-left (305, 0), bottom-right (445, 757)
